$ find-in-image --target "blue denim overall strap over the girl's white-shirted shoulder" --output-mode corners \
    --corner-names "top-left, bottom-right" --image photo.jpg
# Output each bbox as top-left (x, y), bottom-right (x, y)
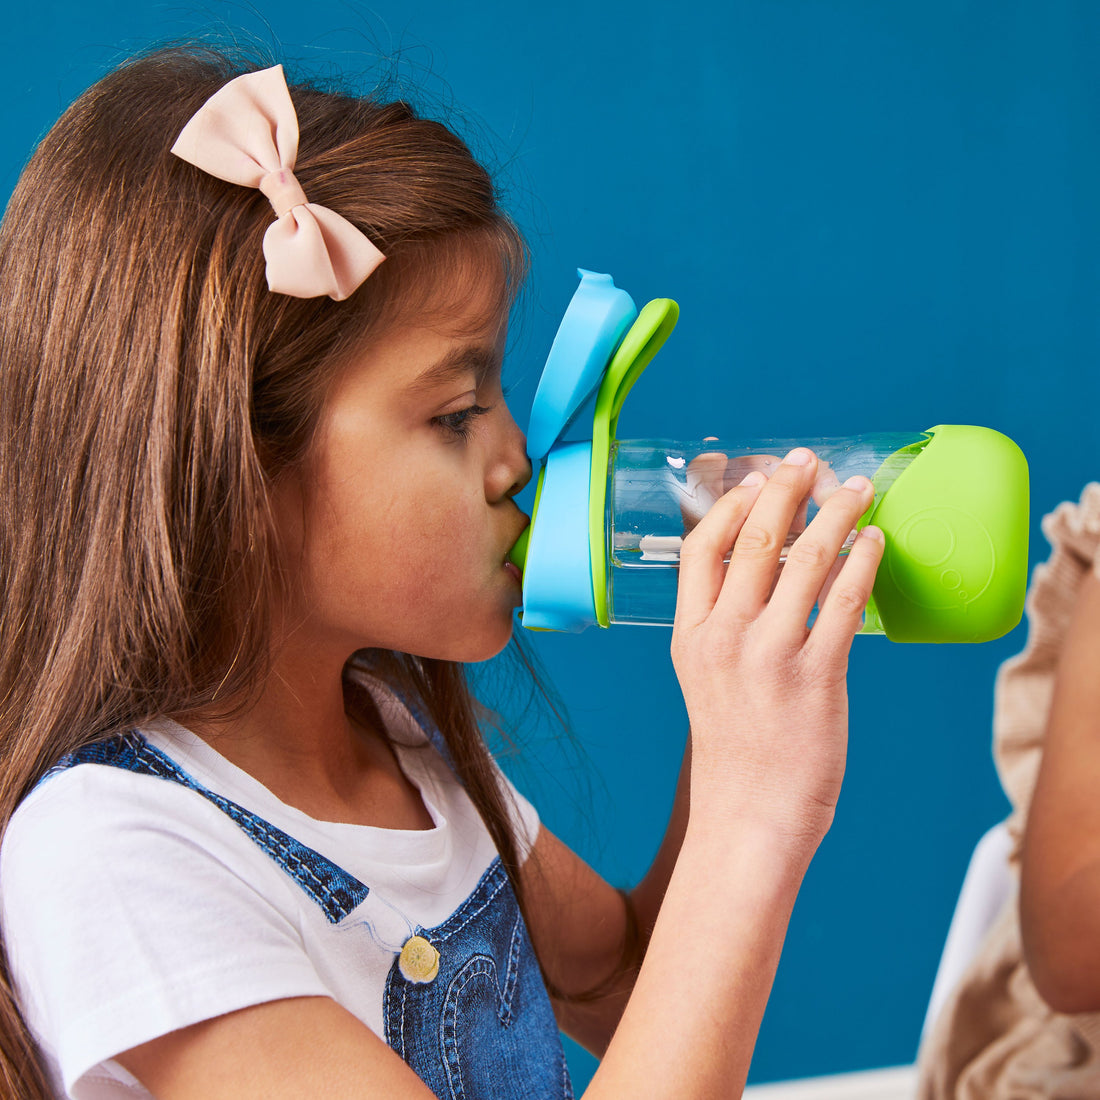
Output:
top-left (47, 732), bottom-right (370, 924)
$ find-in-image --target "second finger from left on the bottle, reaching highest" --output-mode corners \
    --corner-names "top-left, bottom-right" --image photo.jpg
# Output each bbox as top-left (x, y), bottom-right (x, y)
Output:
top-left (715, 447), bottom-right (817, 623)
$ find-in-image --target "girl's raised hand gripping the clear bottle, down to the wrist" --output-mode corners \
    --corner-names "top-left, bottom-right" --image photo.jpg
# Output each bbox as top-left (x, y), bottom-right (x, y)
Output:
top-left (672, 448), bottom-right (883, 859)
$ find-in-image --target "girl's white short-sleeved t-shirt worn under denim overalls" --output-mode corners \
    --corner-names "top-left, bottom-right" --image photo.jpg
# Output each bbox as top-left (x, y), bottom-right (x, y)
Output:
top-left (0, 694), bottom-right (539, 1100)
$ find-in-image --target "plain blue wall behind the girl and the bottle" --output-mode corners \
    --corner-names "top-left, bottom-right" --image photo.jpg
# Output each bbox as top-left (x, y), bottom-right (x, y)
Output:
top-left (0, 0), bottom-right (1100, 1084)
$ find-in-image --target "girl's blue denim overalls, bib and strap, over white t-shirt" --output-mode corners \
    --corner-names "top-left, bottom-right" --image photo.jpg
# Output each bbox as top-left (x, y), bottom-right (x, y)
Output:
top-left (53, 733), bottom-right (573, 1100)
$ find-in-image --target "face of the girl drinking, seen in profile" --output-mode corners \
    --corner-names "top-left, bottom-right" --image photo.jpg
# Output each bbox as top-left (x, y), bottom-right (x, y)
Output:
top-left (276, 292), bottom-right (530, 663)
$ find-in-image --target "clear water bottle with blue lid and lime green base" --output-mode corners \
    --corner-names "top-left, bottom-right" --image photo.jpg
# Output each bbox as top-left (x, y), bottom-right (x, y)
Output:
top-left (510, 271), bottom-right (1029, 641)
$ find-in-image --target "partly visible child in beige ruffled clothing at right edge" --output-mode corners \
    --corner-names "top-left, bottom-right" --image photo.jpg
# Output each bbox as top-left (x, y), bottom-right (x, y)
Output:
top-left (920, 484), bottom-right (1100, 1100)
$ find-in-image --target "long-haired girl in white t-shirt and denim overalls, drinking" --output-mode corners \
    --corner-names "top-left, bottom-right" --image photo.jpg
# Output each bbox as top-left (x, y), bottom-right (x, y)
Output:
top-left (0, 48), bottom-right (881, 1100)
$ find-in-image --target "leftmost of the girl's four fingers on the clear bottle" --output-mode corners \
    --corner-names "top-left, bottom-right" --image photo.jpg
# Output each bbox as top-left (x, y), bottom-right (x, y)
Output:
top-left (674, 472), bottom-right (767, 630)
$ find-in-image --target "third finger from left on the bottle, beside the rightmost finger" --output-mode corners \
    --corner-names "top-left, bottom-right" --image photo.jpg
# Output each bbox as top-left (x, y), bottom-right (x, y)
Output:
top-left (768, 477), bottom-right (875, 637)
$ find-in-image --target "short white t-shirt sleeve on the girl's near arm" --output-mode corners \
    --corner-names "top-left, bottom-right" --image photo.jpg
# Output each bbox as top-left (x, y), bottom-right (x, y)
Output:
top-left (0, 765), bottom-right (328, 1095)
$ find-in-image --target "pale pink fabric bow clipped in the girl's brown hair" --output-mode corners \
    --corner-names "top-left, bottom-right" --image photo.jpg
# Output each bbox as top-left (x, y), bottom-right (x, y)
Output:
top-left (172, 65), bottom-right (386, 301)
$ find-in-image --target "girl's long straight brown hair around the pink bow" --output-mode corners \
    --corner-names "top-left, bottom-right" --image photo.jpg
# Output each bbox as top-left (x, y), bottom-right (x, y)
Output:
top-left (0, 46), bottom-right (527, 1100)
